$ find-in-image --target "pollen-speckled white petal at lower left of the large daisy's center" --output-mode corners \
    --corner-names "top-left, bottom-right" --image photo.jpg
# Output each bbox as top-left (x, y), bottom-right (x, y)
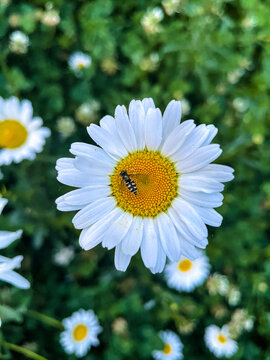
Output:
top-left (102, 209), bottom-right (133, 250)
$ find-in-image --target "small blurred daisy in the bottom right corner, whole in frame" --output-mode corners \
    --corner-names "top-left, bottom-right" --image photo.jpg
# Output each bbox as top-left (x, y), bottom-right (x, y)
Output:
top-left (204, 325), bottom-right (238, 358)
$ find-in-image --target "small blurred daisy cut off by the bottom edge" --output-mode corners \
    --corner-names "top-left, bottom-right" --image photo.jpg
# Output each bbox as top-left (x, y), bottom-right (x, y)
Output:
top-left (152, 330), bottom-right (183, 360)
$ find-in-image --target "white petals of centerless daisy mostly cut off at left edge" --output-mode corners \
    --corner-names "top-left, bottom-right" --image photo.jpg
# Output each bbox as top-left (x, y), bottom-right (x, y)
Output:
top-left (0, 198), bottom-right (30, 289)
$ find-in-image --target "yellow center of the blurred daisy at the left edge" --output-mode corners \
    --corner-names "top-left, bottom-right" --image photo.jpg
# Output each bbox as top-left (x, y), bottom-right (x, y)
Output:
top-left (0, 119), bottom-right (28, 149)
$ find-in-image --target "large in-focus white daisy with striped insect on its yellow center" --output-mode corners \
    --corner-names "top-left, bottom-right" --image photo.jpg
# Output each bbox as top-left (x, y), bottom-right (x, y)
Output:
top-left (56, 99), bottom-right (233, 273)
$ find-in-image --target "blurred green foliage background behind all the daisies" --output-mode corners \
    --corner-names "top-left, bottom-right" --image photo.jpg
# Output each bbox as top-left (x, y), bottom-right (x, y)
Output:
top-left (0, 0), bottom-right (270, 360)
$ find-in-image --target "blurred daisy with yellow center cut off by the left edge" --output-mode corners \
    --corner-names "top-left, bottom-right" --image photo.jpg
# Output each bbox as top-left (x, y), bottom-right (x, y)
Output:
top-left (0, 97), bottom-right (50, 165)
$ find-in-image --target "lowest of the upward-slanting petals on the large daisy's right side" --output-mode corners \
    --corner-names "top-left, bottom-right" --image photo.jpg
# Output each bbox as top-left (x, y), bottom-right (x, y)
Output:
top-left (176, 144), bottom-right (222, 173)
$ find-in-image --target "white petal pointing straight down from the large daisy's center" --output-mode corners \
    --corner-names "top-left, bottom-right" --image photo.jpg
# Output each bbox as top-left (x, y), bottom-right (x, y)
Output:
top-left (141, 218), bottom-right (159, 268)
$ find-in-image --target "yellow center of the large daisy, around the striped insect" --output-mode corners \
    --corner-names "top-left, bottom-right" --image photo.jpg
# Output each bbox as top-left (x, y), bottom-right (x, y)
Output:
top-left (111, 150), bottom-right (178, 217)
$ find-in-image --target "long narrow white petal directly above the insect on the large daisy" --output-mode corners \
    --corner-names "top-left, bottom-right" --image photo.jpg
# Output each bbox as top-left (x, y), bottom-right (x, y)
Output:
top-left (115, 105), bottom-right (137, 152)
